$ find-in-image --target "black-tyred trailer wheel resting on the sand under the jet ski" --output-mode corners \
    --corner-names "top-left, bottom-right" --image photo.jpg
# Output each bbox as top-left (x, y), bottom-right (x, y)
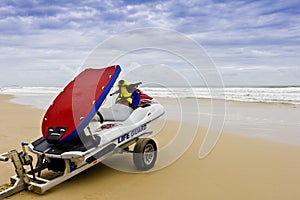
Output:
top-left (133, 138), bottom-right (157, 171)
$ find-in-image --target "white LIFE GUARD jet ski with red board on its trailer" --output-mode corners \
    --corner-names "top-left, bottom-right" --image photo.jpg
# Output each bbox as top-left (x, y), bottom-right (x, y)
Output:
top-left (0, 65), bottom-right (165, 199)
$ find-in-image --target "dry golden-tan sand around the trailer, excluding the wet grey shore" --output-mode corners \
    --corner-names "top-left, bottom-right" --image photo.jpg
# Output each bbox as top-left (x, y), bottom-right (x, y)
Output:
top-left (0, 95), bottom-right (300, 200)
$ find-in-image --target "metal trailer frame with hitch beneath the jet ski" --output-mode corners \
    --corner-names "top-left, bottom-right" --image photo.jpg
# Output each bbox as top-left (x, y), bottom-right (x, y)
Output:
top-left (0, 142), bottom-right (114, 199)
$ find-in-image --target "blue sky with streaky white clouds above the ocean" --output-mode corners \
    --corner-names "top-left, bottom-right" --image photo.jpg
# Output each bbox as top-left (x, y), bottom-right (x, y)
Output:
top-left (0, 0), bottom-right (300, 86)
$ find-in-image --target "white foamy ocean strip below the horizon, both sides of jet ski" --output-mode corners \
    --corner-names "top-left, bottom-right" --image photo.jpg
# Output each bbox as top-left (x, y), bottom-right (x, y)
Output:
top-left (0, 86), bottom-right (300, 109)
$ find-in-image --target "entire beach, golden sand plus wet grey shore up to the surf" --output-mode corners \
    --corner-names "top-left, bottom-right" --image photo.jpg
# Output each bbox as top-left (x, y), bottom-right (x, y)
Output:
top-left (0, 95), bottom-right (300, 200)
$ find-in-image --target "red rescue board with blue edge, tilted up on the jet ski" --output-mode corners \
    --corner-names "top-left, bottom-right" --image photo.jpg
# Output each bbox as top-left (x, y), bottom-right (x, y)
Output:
top-left (42, 65), bottom-right (121, 143)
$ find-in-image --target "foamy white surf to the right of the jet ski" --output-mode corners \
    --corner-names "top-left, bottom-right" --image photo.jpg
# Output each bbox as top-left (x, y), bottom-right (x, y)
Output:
top-left (144, 87), bottom-right (300, 104)
